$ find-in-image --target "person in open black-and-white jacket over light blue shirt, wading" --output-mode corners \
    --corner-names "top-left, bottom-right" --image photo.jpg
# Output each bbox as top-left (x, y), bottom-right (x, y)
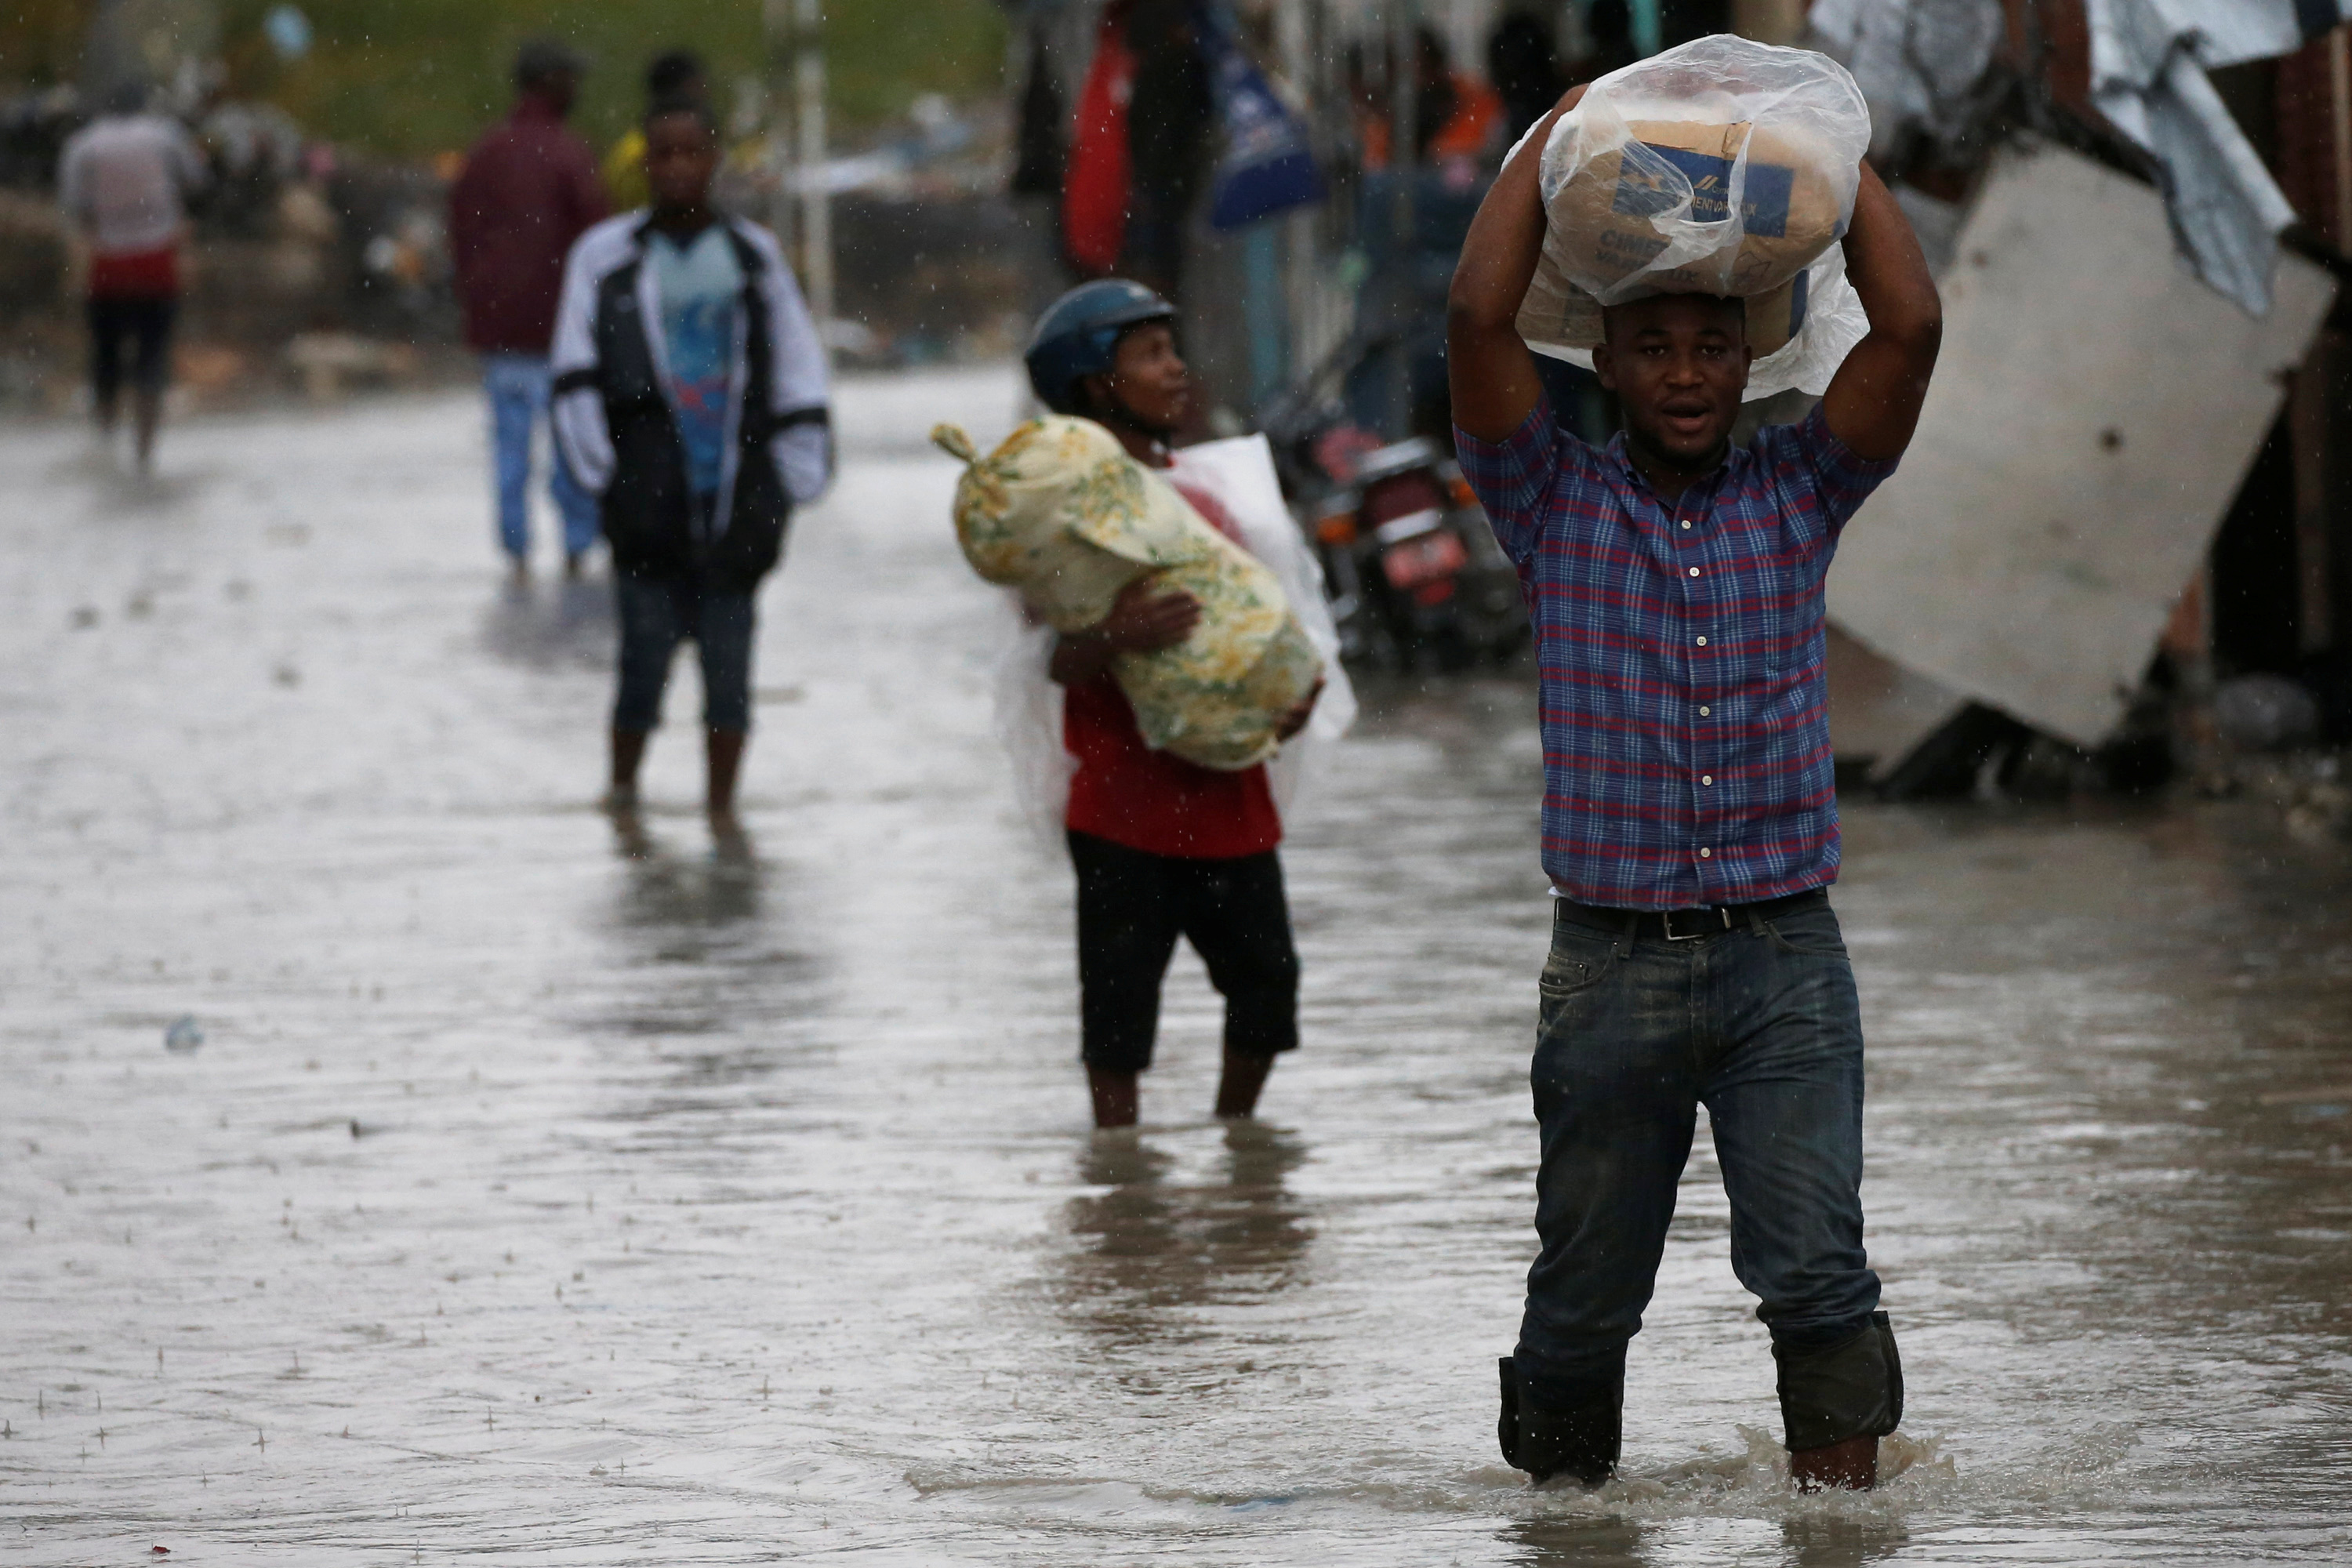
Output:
top-left (553, 99), bottom-right (833, 841)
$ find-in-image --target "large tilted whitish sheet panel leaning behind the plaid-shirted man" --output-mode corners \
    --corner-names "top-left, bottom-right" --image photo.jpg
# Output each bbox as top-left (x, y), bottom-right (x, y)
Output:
top-left (1830, 148), bottom-right (2336, 746)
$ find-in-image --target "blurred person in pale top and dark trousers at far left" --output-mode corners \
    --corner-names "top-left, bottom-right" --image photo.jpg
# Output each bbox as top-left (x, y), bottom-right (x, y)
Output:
top-left (56, 82), bottom-right (205, 473)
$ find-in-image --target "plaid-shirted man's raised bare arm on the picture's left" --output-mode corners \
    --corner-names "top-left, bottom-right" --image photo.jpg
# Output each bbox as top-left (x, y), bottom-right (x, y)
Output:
top-left (1446, 87), bottom-right (1585, 442)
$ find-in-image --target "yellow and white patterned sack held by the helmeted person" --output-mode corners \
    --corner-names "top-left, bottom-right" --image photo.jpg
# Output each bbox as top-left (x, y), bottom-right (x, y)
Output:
top-left (931, 416), bottom-right (1324, 771)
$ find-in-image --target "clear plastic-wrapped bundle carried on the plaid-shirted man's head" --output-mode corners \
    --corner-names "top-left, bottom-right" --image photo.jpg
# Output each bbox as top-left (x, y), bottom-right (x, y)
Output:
top-left (1541, 33), bottom-right (1870, 306)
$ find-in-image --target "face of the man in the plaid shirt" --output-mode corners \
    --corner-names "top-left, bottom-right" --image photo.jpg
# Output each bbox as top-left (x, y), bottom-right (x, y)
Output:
top-left (1592, 294), bottom-right (1755, 470)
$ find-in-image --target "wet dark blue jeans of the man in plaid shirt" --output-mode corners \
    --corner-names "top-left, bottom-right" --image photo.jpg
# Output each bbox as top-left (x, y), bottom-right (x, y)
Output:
top-left (1515, 898), bottom-right (1900, 1441)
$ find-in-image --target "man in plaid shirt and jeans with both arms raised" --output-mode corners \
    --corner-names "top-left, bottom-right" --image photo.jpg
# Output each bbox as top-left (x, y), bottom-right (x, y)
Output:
top-left (1446, 89), bottom-right (1943, 1490)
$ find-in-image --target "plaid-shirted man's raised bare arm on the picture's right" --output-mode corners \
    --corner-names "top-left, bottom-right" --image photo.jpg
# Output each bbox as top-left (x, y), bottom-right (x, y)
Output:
top-left (1820, 165), bottom-right (1943, 459)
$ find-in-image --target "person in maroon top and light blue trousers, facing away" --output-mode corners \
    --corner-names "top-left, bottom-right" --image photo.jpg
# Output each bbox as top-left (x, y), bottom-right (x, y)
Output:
top-left (449, 38), bottom-right (607, 583)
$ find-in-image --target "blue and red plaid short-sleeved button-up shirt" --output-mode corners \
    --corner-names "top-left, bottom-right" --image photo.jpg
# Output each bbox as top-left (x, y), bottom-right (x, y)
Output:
top-left (1454, 402), bottom-right (1896, 909)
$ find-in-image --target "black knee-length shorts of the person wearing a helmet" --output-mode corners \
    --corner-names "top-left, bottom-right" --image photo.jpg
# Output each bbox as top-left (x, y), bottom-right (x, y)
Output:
top-left (1070, 832), bottom-right (1298, 1072)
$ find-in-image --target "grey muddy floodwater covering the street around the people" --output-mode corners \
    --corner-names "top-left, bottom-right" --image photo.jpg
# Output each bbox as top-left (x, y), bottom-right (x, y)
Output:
top-left (0, 372), bottom-right (2352, 1568)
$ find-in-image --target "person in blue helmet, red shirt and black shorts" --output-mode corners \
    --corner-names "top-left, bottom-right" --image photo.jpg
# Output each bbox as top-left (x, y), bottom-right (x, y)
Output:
top-left (1028, 280), bottom-right (1319, 1126)
